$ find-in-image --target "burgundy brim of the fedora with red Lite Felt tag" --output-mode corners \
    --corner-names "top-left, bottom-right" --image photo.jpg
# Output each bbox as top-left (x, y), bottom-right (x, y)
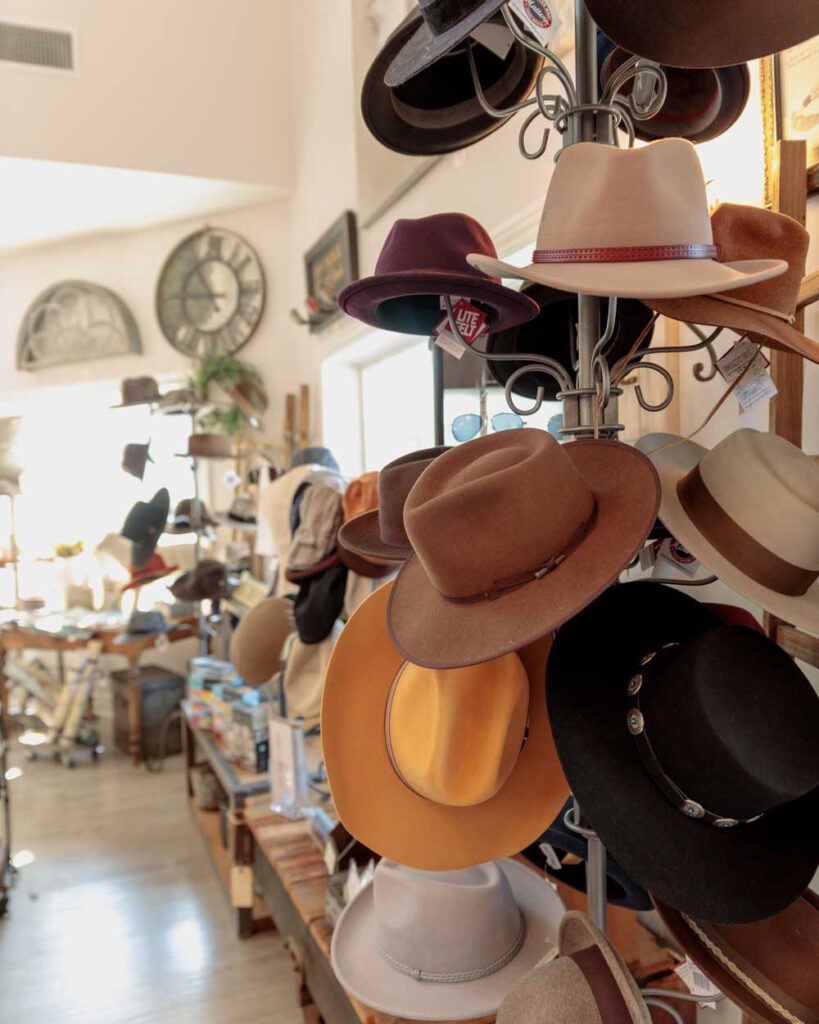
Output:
top-left (337, 270), bottom-right (537, 337)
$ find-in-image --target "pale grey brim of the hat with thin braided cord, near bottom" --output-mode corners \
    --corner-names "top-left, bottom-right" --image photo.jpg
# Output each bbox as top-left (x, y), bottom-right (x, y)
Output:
top-left (331, 860), bottom-right (565, 1021)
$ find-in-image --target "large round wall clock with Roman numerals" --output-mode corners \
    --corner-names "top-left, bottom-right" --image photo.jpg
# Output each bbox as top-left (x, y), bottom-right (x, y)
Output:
top-left (157, 227), bottom-right (264, 358)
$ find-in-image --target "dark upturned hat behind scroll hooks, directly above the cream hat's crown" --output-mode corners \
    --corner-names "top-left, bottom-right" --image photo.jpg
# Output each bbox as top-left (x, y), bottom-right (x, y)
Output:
top-left (598, 46), bottom-right (750, 142)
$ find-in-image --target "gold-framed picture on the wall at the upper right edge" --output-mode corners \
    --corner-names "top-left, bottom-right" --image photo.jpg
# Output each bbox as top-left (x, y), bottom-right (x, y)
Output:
top-left (761, 36), bottom-right (819, 203)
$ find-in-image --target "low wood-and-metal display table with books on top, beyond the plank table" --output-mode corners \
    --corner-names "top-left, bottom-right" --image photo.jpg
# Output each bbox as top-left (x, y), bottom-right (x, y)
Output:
top-left (182, 709), bottom-right (270, 938)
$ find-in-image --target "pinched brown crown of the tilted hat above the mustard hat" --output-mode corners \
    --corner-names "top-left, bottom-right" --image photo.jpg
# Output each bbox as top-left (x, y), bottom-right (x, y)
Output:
top-left (404, 427), bottom-right (595, 598)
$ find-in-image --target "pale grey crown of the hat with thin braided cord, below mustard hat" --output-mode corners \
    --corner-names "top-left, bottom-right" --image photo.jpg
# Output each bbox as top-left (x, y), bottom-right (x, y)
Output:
top-left (373, 860), bottom-right (523, 976)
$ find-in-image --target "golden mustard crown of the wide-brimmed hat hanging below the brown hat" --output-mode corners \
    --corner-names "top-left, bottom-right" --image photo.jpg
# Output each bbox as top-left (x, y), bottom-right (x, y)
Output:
top-left (386, 654), bottom-right (529, 807)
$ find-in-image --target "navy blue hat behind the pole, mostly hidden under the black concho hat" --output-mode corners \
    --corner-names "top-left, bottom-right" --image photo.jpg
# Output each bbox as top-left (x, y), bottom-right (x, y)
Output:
top-left (523, 797), bottom-right (652, 910)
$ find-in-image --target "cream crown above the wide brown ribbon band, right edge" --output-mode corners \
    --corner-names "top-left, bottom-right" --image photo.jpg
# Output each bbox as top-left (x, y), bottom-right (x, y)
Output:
top-left (694, 427), bottom-right (819, 570)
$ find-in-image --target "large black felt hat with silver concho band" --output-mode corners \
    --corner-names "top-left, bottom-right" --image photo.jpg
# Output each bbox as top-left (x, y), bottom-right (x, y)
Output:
top-left (547, 582), bottom-right (819, 924)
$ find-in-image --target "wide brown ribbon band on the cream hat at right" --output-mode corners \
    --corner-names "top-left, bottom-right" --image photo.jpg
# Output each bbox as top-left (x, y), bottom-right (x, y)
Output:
top-left (677, 464), bottom-right (819, 597)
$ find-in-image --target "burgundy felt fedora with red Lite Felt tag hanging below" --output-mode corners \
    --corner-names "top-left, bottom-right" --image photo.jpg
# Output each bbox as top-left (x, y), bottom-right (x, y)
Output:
top-left (338, 213), bottom-right (537, 336)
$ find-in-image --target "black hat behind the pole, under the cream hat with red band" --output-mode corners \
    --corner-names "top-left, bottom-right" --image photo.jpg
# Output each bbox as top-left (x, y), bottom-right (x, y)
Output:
top-left (486, 284), bottom-right (654, 401)
